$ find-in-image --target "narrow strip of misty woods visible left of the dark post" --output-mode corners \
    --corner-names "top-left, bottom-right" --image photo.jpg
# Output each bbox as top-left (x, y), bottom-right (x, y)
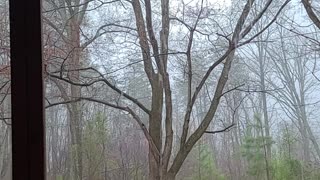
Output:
top-left (0, 0), bottom-right (12, 180)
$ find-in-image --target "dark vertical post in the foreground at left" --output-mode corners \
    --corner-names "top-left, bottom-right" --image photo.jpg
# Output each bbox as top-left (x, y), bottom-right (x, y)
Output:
top-left (9, 0), bottom-right (46, 180)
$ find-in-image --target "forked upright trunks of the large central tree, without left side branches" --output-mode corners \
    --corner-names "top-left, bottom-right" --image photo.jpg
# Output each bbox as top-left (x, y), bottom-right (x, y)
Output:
top-left (130, 0), bottom-right (289, 180)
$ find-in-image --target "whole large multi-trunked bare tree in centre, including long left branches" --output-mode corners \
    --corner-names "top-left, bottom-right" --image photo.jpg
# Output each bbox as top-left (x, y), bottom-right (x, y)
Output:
top-left (50, 0), bottom-right (289, 180)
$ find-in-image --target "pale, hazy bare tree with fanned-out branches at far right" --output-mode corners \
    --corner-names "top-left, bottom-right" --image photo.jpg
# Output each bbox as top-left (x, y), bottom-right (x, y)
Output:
top-left (267, 28), bottom-right (320, 162)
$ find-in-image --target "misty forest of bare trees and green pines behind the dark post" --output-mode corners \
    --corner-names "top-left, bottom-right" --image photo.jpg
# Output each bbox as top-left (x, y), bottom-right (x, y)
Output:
top-left (0, 0), bottom-right (320, 180)
